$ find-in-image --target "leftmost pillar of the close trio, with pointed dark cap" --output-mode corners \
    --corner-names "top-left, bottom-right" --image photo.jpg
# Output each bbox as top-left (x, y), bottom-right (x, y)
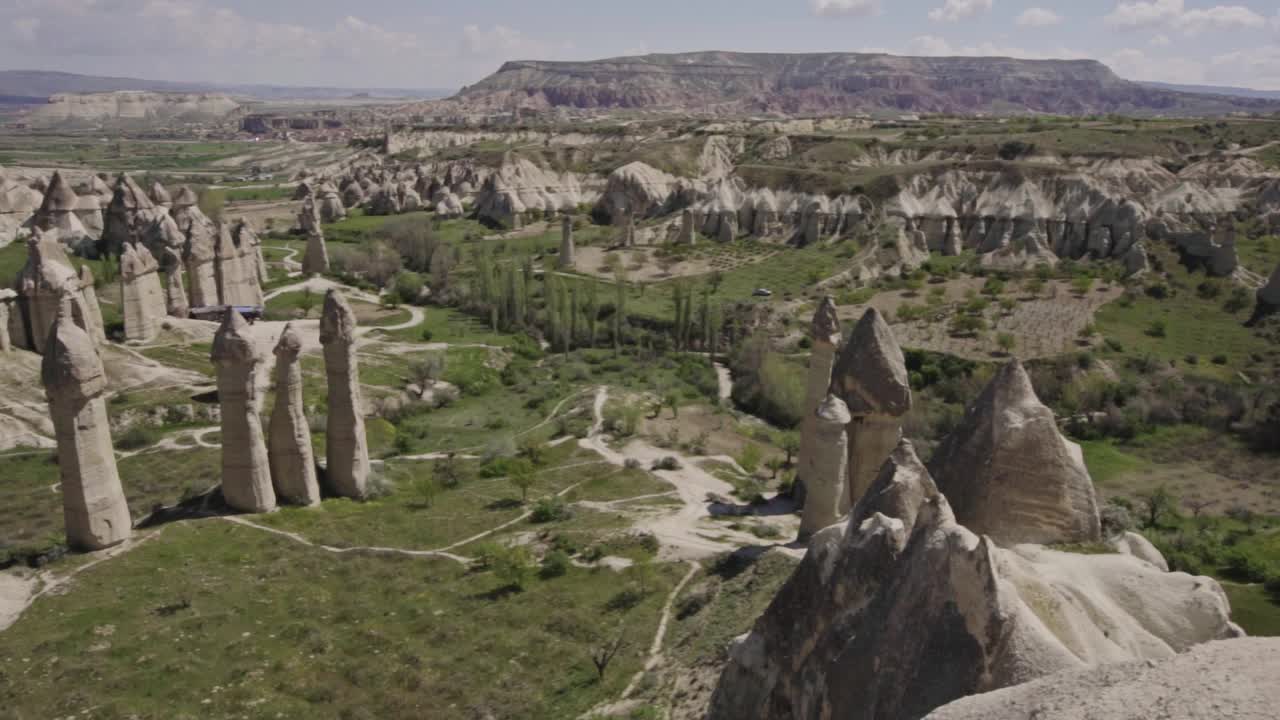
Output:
top-left (210, 309), bottom-right (275, 512)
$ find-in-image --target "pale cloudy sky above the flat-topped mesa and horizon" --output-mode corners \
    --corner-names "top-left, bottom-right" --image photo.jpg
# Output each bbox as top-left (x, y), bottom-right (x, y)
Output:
top-left (0, 0), bottom-right (1280, 90)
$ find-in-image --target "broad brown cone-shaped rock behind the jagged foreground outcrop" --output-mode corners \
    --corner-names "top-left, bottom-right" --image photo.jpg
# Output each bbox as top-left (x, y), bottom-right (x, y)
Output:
top-left (929, 360), bottom-right (1101, 546)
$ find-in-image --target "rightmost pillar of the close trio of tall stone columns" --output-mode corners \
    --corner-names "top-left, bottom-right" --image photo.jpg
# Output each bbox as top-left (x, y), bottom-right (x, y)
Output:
top-left (320, 290), bottom-right (369, 498)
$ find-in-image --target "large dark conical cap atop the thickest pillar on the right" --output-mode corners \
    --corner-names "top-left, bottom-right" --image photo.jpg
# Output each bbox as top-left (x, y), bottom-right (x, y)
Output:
top-left (815, 307), bottom-right (911, 416)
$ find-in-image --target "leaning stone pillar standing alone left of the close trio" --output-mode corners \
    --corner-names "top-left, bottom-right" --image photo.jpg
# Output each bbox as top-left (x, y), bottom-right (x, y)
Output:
top-left (40, 299), bottom-right (133, 551)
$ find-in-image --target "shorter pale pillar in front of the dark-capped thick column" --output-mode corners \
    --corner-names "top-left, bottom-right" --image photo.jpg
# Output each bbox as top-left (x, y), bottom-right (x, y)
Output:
top-left (800, 395), bottom-right (852, 541)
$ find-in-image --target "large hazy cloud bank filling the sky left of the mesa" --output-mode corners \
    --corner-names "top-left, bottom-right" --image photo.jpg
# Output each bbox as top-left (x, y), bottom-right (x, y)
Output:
top-left (0, 0), bottom-right (571, 87)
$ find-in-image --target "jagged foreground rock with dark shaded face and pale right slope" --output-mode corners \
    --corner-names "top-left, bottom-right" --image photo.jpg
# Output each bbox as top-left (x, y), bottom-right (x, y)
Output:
top-left (708, 442), bottom-right (1239, 720)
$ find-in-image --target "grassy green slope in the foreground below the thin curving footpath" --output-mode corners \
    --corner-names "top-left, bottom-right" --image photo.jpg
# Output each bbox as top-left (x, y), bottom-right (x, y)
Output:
top-left (0, 520), bottom-right (684, 720)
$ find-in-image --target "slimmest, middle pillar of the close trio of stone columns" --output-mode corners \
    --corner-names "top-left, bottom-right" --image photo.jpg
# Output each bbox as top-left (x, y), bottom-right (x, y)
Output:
top-left (269, 324), bottom-right (320, 505)
